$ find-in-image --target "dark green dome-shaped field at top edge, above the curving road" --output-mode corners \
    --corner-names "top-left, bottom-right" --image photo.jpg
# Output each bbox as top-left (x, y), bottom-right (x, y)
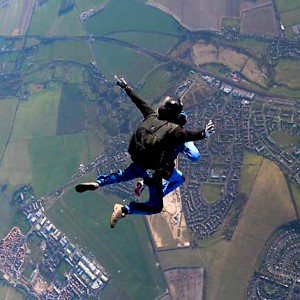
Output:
top-left (85, 0), bottom-right (184, 36)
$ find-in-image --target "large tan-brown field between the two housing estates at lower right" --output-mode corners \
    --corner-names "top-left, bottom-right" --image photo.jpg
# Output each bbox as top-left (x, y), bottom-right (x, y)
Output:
top-left (200, 160), bottom-right (296, 300)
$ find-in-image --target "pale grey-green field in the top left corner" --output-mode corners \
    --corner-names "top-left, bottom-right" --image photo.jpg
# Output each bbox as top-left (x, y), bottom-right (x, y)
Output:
top-left (0, 0), bottom-right (23, 35)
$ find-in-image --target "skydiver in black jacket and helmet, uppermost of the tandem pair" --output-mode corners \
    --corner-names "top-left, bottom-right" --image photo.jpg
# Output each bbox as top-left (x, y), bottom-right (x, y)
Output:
top-left (75, 77), bottom-right (215, 228)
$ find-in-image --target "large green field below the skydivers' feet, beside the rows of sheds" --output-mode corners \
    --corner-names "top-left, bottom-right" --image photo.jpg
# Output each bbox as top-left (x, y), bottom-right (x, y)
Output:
top-left (47, 190), bottom-right (166, 299)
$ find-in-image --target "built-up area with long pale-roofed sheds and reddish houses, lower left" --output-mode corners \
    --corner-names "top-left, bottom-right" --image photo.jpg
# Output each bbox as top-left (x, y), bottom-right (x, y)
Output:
top-left (0, 186), bottom-right (110, 300)
